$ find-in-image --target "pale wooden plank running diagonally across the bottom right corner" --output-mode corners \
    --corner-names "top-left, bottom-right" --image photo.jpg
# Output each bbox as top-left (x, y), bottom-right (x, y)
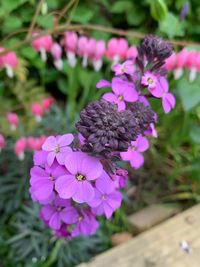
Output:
top-left (78, 204), bottom-right (200, 267)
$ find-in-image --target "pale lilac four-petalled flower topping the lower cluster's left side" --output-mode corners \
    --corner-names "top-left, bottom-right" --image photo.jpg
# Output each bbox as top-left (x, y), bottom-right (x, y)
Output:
top-left (42, 134), bottom-right (74, 166)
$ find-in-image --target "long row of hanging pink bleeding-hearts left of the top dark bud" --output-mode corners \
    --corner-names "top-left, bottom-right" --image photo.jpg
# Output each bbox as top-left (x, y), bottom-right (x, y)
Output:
top-left (32, 32), bottom-right (137, 71)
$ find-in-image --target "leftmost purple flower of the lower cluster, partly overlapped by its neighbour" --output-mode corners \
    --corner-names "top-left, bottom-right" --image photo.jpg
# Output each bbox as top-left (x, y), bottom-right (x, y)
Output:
top-left (30, 163), bottom-right (68, 201)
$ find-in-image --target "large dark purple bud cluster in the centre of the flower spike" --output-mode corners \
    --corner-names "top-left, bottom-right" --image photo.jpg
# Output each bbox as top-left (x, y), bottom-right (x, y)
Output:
top-left (76, 99), bottom-right (154, 154)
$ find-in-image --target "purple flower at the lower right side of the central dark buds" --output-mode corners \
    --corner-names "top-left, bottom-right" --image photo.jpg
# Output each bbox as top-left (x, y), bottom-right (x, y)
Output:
top-left (120, 135), bottom-right (149, 169)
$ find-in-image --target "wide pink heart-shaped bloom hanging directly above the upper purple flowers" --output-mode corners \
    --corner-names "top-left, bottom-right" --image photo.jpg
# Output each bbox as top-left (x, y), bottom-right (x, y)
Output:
top-left (106, 38), bottom-right (128, 64)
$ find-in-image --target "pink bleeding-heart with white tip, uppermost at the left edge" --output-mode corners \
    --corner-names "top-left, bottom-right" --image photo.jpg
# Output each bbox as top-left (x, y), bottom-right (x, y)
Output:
top-left (0, 47), bottom-right (18, 78)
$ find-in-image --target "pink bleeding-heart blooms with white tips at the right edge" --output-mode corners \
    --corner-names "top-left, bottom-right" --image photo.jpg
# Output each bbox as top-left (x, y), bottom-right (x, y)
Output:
top-left (165, 48), bottom-right (200, 82)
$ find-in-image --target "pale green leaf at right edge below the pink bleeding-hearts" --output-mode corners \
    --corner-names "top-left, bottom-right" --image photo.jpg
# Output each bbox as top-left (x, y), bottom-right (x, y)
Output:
top-left (177, 75), bottom-right (200, 111)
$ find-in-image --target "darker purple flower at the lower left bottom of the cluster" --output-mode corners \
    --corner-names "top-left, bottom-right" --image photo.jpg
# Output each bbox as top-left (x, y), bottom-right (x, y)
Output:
top-left (41, 197), bottom-right (79, 230)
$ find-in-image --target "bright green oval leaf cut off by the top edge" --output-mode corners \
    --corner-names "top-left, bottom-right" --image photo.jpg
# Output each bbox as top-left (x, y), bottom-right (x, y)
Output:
top-left (150, 0), bottom-right (168, 21)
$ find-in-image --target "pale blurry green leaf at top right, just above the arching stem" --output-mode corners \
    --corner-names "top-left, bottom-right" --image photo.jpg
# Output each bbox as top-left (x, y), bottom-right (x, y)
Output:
top-left (159, 12), bottom-right (184, 38)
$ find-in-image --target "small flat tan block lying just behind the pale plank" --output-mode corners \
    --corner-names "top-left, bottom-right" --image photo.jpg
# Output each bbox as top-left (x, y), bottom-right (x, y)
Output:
top-left (128, 204), bottom-right (180, 234)
